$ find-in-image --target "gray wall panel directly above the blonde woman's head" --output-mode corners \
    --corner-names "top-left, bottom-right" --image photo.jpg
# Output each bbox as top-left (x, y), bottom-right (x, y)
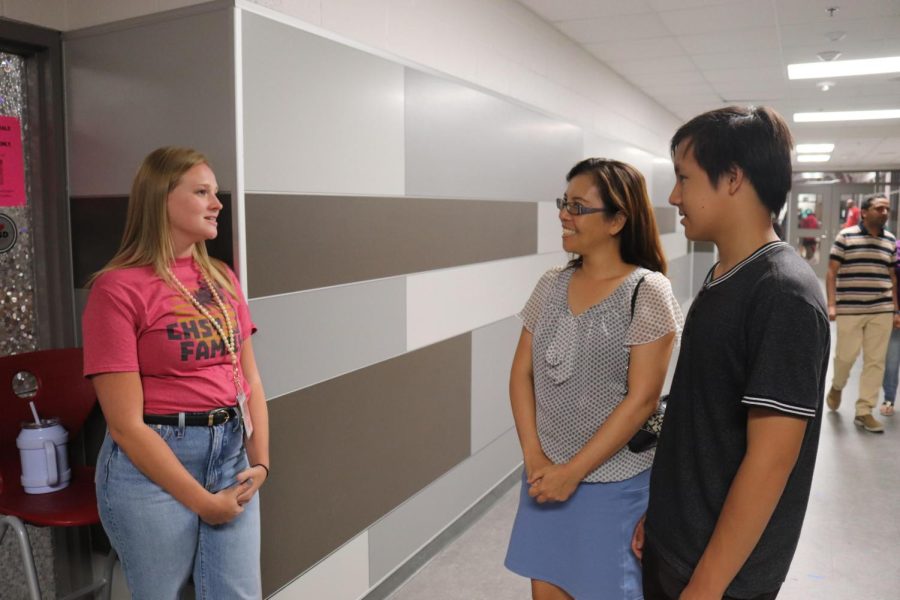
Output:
top-left (64, 9), bottom-right (236, 196)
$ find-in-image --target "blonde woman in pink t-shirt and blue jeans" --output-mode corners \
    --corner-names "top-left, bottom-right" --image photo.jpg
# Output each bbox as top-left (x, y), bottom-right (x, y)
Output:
top-left (83, 147), bottom-right (269, 600)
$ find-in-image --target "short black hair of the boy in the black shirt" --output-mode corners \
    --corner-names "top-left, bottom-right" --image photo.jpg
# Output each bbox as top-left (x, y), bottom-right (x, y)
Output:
top-left (669, 106), bottom-right (794, 215)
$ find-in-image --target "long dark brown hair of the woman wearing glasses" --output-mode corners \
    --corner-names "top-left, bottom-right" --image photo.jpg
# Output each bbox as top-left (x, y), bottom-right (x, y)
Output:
top-left (566, 158), bottom-right (666, 274)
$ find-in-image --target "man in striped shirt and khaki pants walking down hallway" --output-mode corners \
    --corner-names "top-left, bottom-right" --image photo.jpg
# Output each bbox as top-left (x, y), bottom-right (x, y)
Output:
top-left (825, 196), bottom-right (900, 433)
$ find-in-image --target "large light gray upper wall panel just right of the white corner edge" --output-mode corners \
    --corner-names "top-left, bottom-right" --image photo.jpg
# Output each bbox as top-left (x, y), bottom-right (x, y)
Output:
top-left (242, 12), bottom-right (404, 195)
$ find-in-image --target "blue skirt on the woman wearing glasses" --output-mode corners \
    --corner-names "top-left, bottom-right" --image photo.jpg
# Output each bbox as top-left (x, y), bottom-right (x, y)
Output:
top-left (505, 469), bottom-right (650, 600)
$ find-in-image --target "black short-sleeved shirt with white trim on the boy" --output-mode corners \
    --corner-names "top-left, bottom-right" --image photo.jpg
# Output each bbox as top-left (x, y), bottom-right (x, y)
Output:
top-left (646, 242), bottom-right (830, 598)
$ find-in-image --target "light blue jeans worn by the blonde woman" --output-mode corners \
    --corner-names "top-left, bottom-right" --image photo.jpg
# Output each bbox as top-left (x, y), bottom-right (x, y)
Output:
top-left (96, 421), bottom-right (262, 600)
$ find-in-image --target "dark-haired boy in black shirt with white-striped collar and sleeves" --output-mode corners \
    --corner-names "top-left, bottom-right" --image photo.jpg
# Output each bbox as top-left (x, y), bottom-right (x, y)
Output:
top-left (633, 106), bottom-right (830, 600)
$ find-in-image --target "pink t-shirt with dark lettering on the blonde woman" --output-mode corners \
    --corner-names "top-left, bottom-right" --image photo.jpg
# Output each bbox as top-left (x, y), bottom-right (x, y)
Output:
top-left (82, 258), bottom-right (256, 415)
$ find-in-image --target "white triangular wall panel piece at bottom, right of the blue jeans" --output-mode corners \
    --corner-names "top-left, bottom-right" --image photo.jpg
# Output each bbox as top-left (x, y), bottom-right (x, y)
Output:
top-left (269, 531), bottom-right (369, 600)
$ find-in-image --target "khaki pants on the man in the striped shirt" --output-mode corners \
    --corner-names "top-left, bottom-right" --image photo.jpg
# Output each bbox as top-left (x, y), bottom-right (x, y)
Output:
top-left (831, 313), bottom-right (894, 415)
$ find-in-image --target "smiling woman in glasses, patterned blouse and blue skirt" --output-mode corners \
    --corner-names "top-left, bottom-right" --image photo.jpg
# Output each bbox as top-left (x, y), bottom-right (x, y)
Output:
top-left (506, 158), bottom-right (683, 600)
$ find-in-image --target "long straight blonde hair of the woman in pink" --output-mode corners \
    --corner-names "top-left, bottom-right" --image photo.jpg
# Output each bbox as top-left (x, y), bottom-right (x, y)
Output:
top-left (88, 146), bottom-right (237, 297)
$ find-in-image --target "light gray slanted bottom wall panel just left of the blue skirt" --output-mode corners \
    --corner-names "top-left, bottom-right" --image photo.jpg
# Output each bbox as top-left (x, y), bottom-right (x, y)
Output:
top-left (369, 430), bottom-right (522, 585)
